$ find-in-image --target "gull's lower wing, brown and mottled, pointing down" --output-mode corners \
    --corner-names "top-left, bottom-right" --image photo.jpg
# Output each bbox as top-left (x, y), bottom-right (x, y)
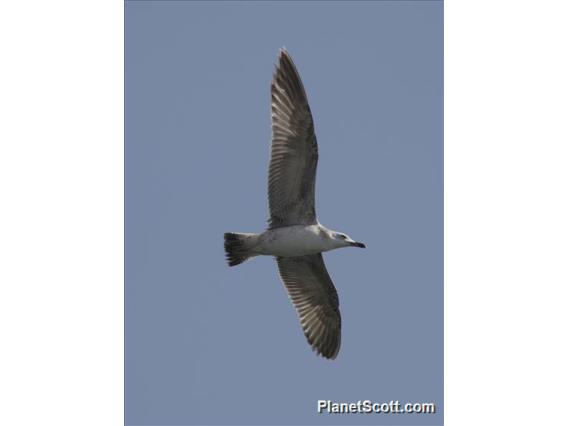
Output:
top-left (277, 253), bottom-right (341, 359)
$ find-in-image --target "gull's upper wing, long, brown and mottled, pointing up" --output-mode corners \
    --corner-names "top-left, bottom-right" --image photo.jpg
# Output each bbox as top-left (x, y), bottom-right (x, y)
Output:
top-left (268, 50), bottom-right (318, 229)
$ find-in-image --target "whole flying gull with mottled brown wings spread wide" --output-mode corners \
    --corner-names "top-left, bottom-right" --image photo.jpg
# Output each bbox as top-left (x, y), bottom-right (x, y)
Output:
top-left (224, 48), bottom-right (365, 359)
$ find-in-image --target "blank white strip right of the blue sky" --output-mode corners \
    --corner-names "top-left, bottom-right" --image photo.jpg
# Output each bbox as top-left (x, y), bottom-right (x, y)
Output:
top-left (445, 0), bottom-right (568, 426)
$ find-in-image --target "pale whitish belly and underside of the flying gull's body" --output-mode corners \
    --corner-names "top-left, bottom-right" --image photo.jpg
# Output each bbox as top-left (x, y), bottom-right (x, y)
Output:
top-left (254, 225), bottom-right (337, 257)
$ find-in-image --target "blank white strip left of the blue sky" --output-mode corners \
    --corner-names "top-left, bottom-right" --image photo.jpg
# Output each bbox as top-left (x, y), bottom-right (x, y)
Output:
top-left (0, 0), bottom-right (124, 426)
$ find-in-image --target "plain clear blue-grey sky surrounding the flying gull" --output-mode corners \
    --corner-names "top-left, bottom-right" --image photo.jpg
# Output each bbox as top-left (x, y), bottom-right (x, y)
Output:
top-left (125, 1), bottom-right (443, 425)
